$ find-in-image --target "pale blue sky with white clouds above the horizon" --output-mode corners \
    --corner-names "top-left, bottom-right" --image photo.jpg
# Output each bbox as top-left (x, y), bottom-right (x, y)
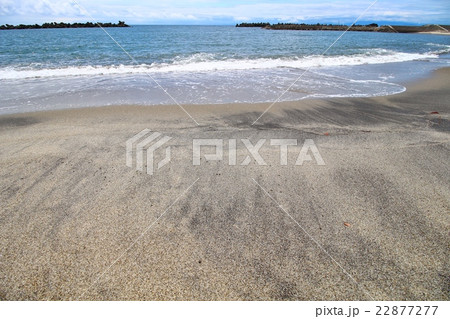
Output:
top-left (0, 0), bottom-right (450, 25)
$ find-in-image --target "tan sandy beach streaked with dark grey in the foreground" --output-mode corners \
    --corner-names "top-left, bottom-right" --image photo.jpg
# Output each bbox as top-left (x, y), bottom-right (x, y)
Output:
top-left (0, 68), bottom-right (450, 300)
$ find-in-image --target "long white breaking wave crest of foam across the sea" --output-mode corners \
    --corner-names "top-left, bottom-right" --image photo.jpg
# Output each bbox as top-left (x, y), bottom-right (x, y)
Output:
top-left (0, 47), bottom-right (442, 80)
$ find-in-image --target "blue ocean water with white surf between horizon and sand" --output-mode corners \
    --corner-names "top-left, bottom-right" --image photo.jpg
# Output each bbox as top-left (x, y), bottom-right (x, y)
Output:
top-left (0, 26), bottom-right (450, 114)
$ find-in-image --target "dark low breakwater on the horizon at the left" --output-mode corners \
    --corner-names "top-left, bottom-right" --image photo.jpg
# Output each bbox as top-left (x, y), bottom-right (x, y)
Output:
top-left (0, 21), bottom-right (129, 30)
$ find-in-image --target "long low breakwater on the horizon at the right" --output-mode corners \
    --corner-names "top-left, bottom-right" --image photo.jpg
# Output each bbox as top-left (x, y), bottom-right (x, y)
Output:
top-left (236, 22), bottom-right (450, 34)
